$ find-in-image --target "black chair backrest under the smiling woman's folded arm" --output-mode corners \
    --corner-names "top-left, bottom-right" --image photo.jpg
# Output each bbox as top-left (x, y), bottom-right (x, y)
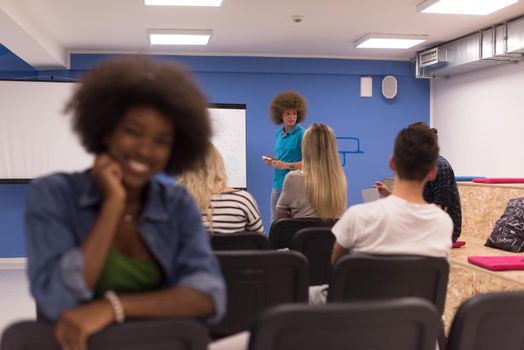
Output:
top-left (0, 318), bottom-right (208, 350)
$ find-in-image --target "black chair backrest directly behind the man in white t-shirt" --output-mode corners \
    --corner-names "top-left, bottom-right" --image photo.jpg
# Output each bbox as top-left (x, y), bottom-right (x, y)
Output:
top-left (328, 254), bottom-right (449, 315)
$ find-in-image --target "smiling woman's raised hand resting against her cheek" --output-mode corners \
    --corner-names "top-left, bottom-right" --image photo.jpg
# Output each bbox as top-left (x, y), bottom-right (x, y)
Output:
top-left (91, 153), bottom-right (126, 200)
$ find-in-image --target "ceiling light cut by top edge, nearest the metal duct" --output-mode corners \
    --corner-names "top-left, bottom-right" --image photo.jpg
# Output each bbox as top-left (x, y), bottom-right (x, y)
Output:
top-left (417, 0), bottom-right (518, 15)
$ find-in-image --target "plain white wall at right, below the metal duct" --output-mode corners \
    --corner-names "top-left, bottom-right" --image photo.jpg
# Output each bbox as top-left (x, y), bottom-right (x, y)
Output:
top-left (433, 62), bottom-right (524, 178)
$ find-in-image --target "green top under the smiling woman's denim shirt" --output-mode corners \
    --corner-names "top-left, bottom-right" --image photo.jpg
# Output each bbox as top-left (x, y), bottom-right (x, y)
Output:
top-left (95, 248), bottom-right (164, 297)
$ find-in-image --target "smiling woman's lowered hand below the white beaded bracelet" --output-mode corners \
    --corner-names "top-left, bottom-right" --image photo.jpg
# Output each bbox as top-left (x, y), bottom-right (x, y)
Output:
top-left (55, 299), bottom-right (114, 350)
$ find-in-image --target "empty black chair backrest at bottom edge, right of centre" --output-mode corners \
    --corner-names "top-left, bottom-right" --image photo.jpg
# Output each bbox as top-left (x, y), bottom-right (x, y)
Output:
top-left (249, 298), bottom-right (439, 350)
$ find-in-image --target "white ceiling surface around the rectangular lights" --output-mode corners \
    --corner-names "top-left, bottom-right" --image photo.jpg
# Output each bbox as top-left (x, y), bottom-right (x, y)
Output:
top-left (0, 0), bottom-right (524, 68)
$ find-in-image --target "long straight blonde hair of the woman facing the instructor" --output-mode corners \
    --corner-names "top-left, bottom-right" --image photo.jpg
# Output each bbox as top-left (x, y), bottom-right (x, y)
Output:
top-left (302, 123), bottom-right (347, 219)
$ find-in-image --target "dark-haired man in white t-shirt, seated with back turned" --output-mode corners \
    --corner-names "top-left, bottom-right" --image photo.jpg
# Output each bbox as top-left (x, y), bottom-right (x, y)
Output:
top-left (331, 126), bottom-right (453, 264)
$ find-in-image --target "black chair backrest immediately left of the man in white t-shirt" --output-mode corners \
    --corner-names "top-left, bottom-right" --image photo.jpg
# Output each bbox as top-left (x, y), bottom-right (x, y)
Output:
top-left (291, 227), bottom-right (335, 286)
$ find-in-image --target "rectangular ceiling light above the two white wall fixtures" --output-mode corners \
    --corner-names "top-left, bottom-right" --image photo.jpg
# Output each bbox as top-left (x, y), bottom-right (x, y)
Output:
top-left (353, 34), bottom-right (428, 49)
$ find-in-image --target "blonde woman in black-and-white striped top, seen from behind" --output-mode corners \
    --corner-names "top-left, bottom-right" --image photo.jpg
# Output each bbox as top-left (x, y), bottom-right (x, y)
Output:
top-left (177, 146), bottom-right (264, 234)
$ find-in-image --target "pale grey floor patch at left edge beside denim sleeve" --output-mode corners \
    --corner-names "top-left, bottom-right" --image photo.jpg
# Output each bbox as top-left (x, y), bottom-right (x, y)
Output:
top-left (0, 266), bottom-right (35, 333)
